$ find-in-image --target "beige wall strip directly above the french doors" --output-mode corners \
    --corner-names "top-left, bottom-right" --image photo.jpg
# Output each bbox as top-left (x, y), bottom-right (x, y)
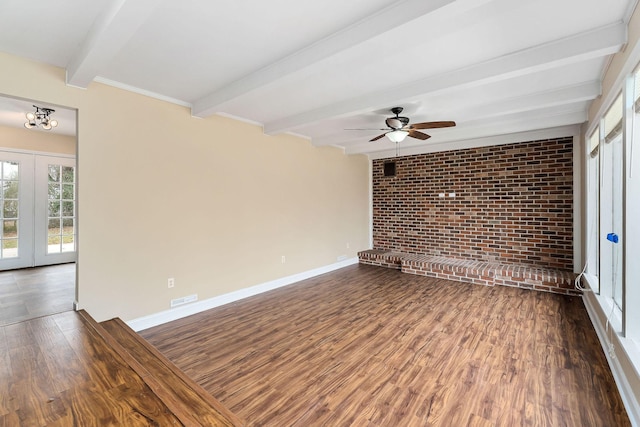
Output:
top-left (0, 126), bottom-right (76, 155)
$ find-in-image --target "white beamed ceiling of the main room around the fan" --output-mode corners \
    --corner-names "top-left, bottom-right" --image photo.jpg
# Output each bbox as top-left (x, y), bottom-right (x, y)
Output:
top-left (0, 0), bottom-right (637, 158)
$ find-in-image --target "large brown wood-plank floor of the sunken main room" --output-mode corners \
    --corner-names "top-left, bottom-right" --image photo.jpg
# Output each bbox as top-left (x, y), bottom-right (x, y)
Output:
top-left (141, 265), bottom-right (630, 427)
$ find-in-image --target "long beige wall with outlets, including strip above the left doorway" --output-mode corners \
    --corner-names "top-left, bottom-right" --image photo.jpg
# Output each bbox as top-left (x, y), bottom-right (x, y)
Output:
top-left (0, 54), bottom-right (370, 321)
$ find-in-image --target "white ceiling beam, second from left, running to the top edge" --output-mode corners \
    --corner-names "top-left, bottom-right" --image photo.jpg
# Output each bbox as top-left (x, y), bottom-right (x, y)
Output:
top-left (191, 0), bottom-right (464, 117)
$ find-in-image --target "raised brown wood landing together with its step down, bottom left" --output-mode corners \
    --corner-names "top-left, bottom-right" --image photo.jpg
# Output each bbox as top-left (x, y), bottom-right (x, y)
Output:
top-left (0, 311), bottom-right (244, 427)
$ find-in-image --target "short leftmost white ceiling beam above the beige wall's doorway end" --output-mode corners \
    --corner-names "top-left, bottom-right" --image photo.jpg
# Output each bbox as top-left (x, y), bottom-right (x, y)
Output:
top-left (67, 0), bottom-right (159, 88)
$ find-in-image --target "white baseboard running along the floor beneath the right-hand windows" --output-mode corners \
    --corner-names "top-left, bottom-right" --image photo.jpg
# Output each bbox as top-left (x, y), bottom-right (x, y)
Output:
top-left (582, 294), bottom-right (640, 427)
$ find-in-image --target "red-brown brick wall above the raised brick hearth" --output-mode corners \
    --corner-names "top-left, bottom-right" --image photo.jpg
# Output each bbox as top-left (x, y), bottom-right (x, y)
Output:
top-left (373, 138), bottom-right (573, 270)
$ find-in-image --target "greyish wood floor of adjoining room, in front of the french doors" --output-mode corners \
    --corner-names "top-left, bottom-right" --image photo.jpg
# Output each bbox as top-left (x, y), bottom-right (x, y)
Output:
top-left (0, 263), bottom-right (76, 325)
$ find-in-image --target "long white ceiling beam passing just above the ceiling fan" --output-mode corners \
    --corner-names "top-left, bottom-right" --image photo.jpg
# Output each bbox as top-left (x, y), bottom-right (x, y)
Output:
top-left (264, 23), bottom-right (627, 135)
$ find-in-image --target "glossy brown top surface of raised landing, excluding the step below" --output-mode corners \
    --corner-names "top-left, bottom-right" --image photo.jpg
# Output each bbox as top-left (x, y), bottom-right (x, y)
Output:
top-left (0, 313), bottom-right (182, 427)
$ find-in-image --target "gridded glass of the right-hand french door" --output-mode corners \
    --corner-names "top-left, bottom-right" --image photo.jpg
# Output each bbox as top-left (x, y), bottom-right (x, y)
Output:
top-left (47, 165), bottom-right (76, 254)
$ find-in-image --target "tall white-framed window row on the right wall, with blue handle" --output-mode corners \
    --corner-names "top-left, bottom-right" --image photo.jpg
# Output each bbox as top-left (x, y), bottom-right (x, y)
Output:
top-left (585, 66), bottom-right (640, 350)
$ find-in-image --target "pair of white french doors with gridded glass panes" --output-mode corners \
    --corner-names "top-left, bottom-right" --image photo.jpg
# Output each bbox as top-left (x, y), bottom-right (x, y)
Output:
top-left (0, 151), bottom-right (77, 270)
